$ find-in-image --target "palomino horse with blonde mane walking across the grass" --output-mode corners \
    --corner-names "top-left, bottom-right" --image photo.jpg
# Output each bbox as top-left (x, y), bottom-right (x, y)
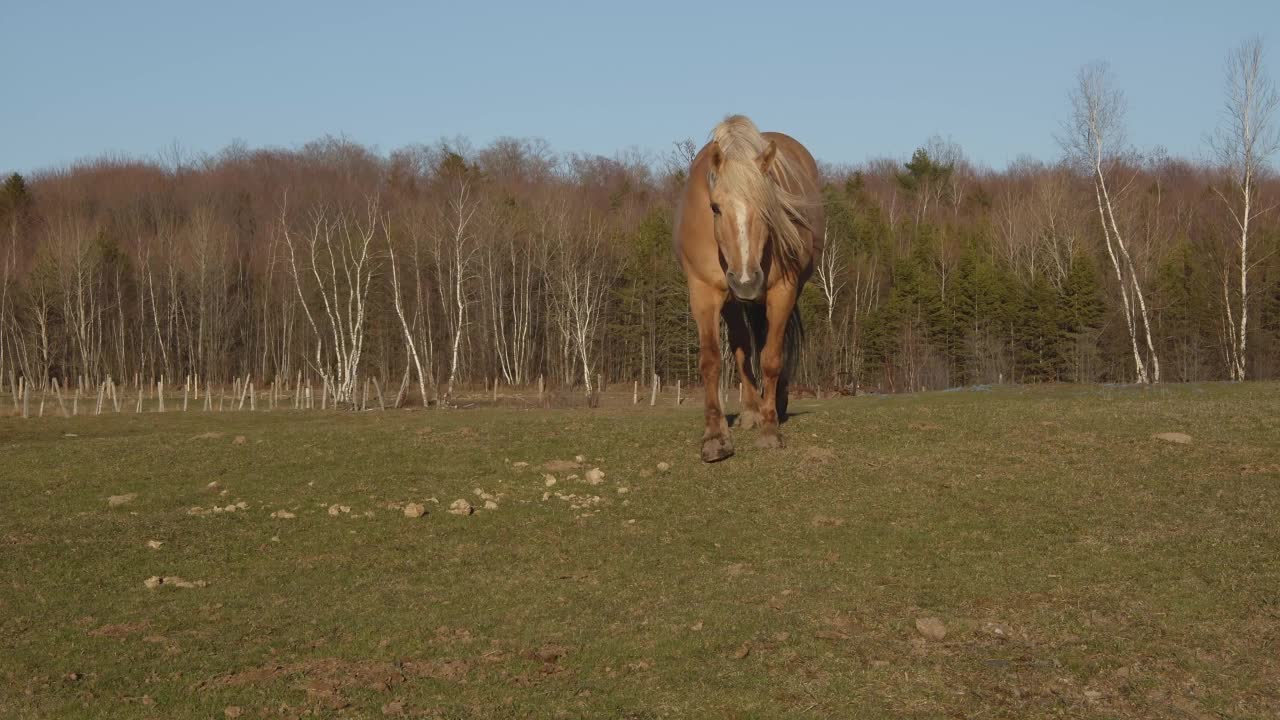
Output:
top-left (675, 115), bottom-right (824, 462)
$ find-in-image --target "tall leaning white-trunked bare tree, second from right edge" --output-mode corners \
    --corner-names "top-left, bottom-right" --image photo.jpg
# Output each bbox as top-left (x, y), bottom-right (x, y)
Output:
top-left (1059, 63), bottom-right (1160, 383)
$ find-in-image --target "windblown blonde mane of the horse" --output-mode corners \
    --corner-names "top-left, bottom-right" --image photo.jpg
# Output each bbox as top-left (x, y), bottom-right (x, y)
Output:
top-left (712, 115), bottom-right (813, 272)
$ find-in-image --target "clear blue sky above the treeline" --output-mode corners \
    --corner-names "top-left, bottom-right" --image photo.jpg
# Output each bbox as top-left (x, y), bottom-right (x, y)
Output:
top-left (0, 0), bottom-right (1280, 172)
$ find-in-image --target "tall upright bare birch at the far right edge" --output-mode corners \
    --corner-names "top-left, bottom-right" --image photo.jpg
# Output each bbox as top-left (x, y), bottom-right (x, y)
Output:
top-left (1211, 37), bottom-right (1280, 380)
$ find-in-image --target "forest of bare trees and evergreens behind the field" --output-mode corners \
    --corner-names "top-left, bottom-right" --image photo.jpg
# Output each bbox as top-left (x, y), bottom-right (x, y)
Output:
top-left (0, 58), bottom-right (1280, 404)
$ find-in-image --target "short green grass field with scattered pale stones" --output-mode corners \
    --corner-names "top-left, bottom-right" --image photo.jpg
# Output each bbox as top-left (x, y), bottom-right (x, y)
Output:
top-left (0, 384), bottom-right (1280, 719)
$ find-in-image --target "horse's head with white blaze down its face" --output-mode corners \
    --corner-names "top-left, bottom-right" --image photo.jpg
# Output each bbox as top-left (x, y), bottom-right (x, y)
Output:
top-left (708, 141), bottom-right (777, 300)
